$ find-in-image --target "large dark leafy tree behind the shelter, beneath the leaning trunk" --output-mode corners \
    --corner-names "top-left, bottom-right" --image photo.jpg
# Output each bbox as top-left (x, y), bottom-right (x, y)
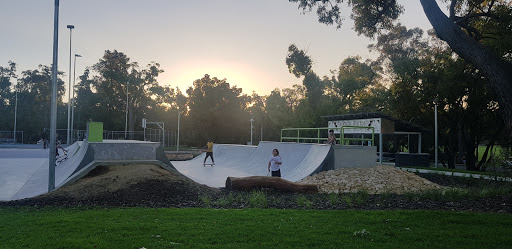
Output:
top-left (370, 26), bottom-right (503, 169)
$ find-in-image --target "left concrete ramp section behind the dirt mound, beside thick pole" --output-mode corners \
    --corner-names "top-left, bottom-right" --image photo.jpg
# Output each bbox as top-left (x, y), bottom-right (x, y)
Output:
top-left (0, 140), bottom-right (178, 201)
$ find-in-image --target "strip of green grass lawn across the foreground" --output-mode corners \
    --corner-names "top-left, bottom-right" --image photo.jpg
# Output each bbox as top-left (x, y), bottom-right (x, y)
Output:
top-left (0, 208), bottom-right (512, 249)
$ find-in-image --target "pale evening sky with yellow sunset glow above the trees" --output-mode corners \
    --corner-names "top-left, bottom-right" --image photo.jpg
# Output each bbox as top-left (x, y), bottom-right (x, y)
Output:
top-left (0, 0), bottom-right (436, 102)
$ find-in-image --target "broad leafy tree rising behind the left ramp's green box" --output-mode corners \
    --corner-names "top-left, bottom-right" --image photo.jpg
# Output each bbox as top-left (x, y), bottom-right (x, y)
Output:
top-left (91, 50), bottom-right (163, 131)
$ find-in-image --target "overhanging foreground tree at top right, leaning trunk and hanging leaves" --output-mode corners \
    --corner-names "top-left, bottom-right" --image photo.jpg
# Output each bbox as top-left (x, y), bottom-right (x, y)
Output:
top-left (289, 0), bottom-right (512, 129)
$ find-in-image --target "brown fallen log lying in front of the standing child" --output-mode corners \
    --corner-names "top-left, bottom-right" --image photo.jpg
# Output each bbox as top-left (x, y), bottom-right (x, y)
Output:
top-left (226, 176), bottom-right (318, 193)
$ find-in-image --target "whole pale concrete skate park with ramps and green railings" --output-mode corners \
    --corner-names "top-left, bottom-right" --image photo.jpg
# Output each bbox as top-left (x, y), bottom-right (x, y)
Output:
top-left (0, 114), bottom-right (432, 200)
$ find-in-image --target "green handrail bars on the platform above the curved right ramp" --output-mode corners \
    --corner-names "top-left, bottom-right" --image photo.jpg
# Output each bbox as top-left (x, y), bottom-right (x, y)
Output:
top-left (281, 126), bottom-right (375, 145)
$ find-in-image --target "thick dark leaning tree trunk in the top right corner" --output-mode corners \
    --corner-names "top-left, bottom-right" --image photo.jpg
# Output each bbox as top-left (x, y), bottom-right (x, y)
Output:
top-left (420, 0), bottom-right (512, 129)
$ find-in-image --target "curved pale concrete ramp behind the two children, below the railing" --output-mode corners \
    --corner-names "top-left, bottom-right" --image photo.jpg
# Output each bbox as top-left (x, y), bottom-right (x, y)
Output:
top-left (172, 142), bottom-right (333, 187)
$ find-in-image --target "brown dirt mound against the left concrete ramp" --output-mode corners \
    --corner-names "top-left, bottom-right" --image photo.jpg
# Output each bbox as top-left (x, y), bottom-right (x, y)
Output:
top-left (26, 164), bottom-right (219, 207)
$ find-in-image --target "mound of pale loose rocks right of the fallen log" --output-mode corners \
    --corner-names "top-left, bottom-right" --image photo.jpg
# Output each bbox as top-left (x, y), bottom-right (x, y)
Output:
top-left (299, 165), bottom-right (442, 194)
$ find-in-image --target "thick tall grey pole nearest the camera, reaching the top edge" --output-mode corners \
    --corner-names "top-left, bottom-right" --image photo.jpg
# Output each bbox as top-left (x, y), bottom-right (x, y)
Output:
top-left (48, 0), bottom-right (59, 192)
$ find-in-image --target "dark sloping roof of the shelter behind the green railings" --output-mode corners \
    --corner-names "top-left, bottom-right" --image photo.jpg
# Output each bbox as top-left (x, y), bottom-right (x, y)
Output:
top-left (322, 112), bottom-right (431, 132)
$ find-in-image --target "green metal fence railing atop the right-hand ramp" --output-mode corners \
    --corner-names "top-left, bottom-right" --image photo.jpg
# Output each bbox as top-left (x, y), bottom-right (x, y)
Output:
top-left (281, 126), bottom-right (375, 145)
